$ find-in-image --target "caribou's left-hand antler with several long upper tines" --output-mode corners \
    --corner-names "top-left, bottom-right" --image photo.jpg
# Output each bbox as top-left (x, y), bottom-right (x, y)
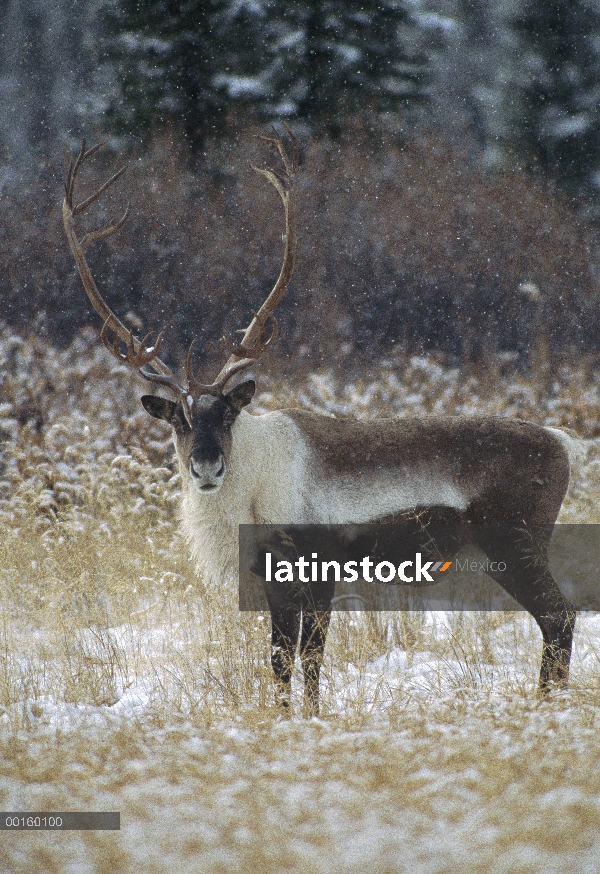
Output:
top-left (63, 140), bottom-right (182, 394)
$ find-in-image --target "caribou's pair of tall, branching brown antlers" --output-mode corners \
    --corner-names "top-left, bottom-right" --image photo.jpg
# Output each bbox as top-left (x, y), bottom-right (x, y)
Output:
top-left (63, 124), bottom-right (298, 416)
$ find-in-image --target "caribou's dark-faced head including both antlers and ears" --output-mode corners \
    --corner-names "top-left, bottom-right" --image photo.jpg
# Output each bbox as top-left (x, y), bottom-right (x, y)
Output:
top-left (63, 125), bottom-right (298, 494)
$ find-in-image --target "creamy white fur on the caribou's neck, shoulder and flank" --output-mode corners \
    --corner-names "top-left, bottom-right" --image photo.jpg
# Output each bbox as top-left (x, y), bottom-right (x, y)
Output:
top-left (181, 411), bottom-right (469, 581)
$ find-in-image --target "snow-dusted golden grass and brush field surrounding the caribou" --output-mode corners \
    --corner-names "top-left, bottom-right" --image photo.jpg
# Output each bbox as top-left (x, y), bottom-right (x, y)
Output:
top-left (0, 331), bottom-right (600, 874)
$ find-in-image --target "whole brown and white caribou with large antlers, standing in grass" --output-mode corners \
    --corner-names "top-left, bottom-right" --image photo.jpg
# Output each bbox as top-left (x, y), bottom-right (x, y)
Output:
top-left (63, 126), bottom-right (575, 715)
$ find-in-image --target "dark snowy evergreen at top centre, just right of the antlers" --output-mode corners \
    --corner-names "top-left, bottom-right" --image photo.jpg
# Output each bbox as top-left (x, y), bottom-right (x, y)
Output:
top-left (265, 0), bottom-right (426, 132)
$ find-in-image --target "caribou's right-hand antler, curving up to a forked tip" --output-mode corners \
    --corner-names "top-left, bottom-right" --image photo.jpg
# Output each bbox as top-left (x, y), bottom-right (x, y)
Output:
top-left (197, 123), bottom-right (298, 394)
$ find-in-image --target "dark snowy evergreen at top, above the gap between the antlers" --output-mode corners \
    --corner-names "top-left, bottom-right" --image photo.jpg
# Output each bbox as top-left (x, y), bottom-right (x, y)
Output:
top-left (104, 0), bottom-right (262, 150)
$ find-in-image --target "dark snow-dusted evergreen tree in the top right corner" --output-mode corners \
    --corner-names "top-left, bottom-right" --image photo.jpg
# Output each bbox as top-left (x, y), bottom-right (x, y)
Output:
top-left (507, 0), bottom-right (600, 195)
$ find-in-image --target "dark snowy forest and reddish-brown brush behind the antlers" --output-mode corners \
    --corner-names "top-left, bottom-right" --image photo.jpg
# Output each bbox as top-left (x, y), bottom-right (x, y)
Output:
top-left (0, 0), bottom-right (600, 369)
